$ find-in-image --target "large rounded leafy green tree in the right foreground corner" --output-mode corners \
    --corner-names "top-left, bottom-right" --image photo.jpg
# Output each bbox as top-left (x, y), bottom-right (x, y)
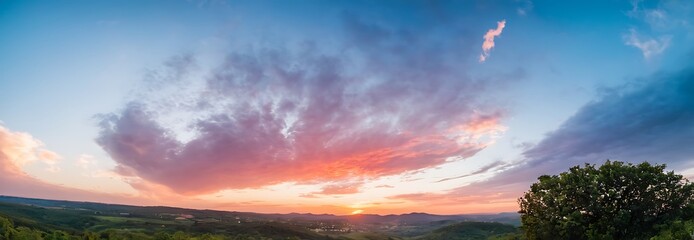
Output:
top-left (518, 161), bottom-right (694, 239)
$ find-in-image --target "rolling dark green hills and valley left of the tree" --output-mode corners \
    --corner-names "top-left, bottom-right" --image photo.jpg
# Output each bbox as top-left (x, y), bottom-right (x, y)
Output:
top-left (0, 196), bottom-right (518, 240)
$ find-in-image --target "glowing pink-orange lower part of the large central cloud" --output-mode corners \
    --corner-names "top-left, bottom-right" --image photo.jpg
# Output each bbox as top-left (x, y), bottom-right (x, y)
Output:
top-left (99, 103), bottom-right (494, 194)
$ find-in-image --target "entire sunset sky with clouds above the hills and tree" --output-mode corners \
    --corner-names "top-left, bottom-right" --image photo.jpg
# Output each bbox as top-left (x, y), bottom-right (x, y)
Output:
top-left (0, 0), bottom-right (694, 215)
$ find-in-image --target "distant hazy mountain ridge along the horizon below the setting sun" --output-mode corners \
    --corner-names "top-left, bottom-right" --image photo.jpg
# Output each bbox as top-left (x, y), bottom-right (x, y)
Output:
top-left (0, 195), bottom-right (520, 226)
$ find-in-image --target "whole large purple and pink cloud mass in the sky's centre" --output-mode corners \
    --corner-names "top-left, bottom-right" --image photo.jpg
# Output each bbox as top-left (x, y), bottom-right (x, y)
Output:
top-left (96, 16), bottom-right (504, 194)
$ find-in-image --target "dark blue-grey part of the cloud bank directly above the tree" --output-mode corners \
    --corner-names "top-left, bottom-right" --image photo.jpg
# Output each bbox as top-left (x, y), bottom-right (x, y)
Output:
top-left (524, 65), bottom-right (694, 169)
